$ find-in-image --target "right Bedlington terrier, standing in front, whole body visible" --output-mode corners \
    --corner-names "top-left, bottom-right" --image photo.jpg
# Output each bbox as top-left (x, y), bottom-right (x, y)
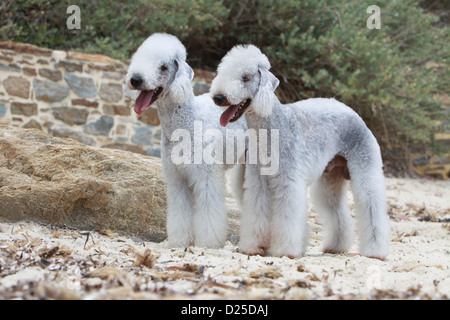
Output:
top-left (211, 45), bottom-right (390, 259)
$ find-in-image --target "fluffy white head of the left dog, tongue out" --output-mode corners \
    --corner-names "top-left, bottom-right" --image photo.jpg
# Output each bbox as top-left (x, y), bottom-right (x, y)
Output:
top-left (126, 33), bottom-right (194, 114)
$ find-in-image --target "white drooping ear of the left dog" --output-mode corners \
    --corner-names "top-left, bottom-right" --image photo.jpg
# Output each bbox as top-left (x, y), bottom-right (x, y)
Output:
top-left (170, 59), bottom-right (194, 103)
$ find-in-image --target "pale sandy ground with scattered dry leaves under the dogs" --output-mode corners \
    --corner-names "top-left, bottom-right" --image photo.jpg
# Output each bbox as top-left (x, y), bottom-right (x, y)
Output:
top-left (0, 178), bottom-right (450, 299)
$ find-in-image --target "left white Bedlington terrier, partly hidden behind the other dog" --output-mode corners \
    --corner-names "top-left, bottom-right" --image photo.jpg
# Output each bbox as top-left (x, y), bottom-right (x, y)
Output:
top-left (126, 33), bottom-right (246, 248)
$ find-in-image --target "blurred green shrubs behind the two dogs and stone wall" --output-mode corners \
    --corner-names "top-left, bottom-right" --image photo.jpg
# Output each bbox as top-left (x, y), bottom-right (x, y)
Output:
top-left (0, 0), bottom-right (450, 168)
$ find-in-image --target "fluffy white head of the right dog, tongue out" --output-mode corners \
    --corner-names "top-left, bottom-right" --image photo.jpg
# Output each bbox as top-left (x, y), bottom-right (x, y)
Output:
top-left (211, 45), bottom-right (280, 127)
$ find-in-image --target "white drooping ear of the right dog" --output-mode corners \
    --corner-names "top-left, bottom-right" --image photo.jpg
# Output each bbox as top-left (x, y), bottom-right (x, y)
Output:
top-left (252, 68), bottom-right (280, 117)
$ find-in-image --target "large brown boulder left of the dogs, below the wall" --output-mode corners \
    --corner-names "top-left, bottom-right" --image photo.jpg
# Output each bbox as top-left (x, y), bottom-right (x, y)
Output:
top-left (0, 126), bottom-right (166, 241)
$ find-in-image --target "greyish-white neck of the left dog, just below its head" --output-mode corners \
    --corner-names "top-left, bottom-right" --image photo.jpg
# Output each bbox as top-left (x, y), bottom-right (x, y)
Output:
top-left (157, 89), bottom-right (195, 137)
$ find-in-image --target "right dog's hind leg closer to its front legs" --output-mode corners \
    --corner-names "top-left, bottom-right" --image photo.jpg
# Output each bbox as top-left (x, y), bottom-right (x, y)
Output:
top-left (310, 167), bottom-right (354, 253)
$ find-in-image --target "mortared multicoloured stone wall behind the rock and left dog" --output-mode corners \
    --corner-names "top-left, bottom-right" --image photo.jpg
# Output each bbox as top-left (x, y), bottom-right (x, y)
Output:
top-left (0, 42), bottom-right (213, 156)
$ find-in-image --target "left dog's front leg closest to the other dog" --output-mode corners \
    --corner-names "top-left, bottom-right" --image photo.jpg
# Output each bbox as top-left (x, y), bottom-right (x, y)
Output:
top-left (191, 169), bottom-right (228, 248)
